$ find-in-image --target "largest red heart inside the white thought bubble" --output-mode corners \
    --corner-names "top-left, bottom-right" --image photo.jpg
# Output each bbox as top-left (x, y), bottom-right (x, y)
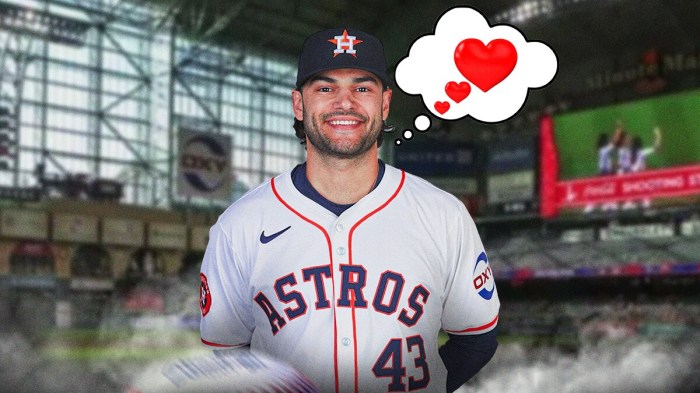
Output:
top-left (455, 38), bottom-right (518, 92)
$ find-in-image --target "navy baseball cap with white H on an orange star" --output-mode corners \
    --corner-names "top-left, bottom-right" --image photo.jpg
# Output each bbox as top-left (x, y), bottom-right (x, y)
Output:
top-left (297, 28), bottom-right (389, 89)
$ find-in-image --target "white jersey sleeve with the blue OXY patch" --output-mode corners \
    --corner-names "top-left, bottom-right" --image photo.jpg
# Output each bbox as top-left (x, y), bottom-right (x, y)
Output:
top-left (442, 204), bottom-right (500, 334)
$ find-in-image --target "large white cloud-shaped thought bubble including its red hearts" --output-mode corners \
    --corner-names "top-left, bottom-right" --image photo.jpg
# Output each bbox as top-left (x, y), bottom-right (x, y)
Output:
top-left (395, 7), bottom-right (557, 123)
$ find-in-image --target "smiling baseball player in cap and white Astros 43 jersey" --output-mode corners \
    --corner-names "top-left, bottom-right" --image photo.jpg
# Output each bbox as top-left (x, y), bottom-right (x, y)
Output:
top-left (200, 29), bottom-right (499, 392)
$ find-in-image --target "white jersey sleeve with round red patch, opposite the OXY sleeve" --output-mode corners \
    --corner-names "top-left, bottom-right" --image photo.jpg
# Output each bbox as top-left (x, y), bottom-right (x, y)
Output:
top-left (199, 222), bottom-right (254, 348)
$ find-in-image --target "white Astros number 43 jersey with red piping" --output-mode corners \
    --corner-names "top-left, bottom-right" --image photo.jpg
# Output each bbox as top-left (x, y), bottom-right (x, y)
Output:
top-left (201, 165), bottom-right (499, 392)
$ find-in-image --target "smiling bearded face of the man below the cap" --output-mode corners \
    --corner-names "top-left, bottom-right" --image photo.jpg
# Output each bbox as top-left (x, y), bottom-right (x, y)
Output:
top-left (292, 69), bottom-right (391, 158)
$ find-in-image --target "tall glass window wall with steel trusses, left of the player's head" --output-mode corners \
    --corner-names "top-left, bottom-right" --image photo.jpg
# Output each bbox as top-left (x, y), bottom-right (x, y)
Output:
top-left (0, 0), bottom-right (303, 206)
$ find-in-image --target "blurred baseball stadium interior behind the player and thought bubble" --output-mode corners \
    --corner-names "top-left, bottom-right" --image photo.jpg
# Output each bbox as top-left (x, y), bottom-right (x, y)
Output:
top-left (0, 0), bottom-right (700, 393)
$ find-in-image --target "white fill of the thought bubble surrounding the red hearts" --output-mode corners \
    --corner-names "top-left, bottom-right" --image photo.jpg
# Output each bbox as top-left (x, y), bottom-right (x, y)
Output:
top-left (395, 6), bottom-right (559, 123)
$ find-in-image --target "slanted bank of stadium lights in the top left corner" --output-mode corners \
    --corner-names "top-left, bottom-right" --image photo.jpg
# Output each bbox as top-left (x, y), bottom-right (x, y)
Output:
top-left (0, 3), bottom-right (91, 46)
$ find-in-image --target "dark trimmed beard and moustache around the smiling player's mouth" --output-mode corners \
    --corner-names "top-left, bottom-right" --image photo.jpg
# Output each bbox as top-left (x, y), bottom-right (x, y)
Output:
top-left (304, 111), bottom-right (382, 159)
